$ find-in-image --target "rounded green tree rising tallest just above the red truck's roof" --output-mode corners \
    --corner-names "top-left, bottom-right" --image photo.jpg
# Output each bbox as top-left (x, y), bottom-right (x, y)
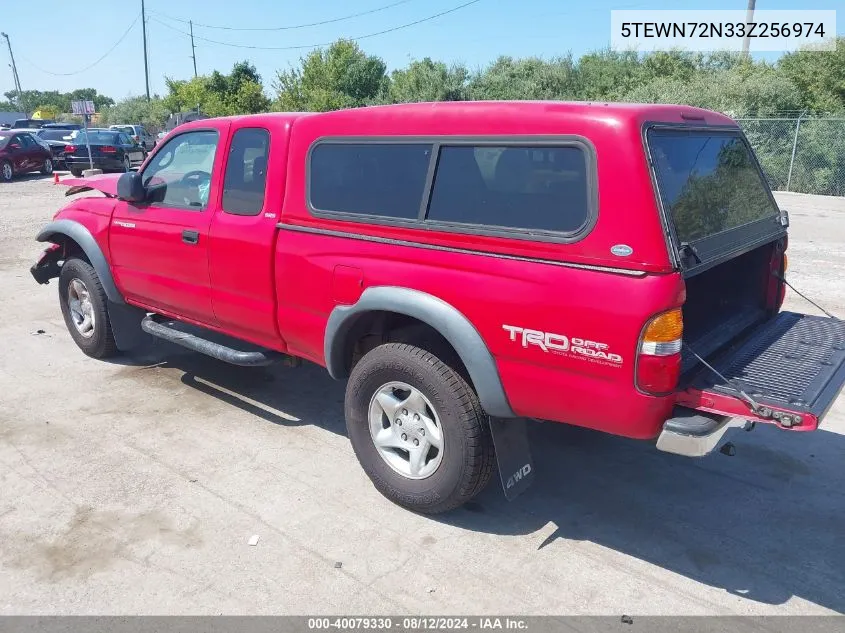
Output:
top-left (273, 40), bottom-right (389, 112)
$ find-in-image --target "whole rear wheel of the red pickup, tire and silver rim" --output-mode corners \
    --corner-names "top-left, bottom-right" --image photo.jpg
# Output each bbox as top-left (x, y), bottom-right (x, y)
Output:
top-left (345, 343), bottom-right (495, 514)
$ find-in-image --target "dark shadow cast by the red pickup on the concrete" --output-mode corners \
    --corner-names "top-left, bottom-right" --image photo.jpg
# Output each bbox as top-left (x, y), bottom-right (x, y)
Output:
top-left (115, 342), bottom-right (845, 612)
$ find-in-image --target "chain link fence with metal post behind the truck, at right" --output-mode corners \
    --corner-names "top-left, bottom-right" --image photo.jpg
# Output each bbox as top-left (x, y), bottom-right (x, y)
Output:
top-left (737, 117), bottom-right (845, 196)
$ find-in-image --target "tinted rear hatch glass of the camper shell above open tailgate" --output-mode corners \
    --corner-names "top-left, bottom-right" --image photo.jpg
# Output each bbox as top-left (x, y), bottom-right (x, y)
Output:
top-left (648, 129), bottom-right (778, 242)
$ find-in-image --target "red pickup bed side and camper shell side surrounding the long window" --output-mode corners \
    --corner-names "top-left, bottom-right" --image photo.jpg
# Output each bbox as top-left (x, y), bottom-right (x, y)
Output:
top-left (276, 103), bottom-right (725, 438)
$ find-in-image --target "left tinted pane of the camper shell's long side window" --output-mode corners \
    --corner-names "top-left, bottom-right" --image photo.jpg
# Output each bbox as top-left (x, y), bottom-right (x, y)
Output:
top-left (309, 142), bottom-right (431, 219)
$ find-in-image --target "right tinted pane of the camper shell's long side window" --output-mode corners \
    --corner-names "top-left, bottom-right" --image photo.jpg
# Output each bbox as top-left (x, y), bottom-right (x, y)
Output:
top-left (427, 145), bottom-right (590, 233)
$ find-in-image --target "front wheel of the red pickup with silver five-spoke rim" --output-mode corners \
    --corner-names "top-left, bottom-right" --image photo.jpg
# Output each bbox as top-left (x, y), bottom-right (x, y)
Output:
top-left (59, 258), bottom-right (117, 358)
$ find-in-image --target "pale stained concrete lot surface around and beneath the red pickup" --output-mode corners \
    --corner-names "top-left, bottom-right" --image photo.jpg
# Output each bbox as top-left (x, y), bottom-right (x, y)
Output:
top-left (0, 178), bottom-right (845, 615)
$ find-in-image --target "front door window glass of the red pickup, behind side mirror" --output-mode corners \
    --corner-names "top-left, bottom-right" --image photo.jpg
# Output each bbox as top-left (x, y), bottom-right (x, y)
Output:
top-left (141, 130), bottom-right (219, 211)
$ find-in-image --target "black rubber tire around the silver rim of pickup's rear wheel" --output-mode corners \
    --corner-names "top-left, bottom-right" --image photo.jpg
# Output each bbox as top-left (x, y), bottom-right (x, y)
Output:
top-left (345, 343), bottom-right (495, 514)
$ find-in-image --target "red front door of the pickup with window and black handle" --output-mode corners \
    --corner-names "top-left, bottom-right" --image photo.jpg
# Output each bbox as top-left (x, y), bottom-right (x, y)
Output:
top-left (109, 123), bottom-right (228, 325)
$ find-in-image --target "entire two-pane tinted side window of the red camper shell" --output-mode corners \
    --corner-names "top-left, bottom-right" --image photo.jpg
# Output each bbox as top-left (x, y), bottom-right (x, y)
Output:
top-left (308, 137), bottom-right (594, 239)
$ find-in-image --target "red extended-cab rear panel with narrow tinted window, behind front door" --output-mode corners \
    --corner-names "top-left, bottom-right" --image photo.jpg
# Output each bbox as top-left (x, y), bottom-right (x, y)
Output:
top-left (209, 122), bottom-right (287, 349)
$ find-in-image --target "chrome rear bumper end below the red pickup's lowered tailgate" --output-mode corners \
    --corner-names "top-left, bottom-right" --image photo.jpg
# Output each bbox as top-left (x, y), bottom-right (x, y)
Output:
top-left (657, 407), bottom-right (753, 457)
